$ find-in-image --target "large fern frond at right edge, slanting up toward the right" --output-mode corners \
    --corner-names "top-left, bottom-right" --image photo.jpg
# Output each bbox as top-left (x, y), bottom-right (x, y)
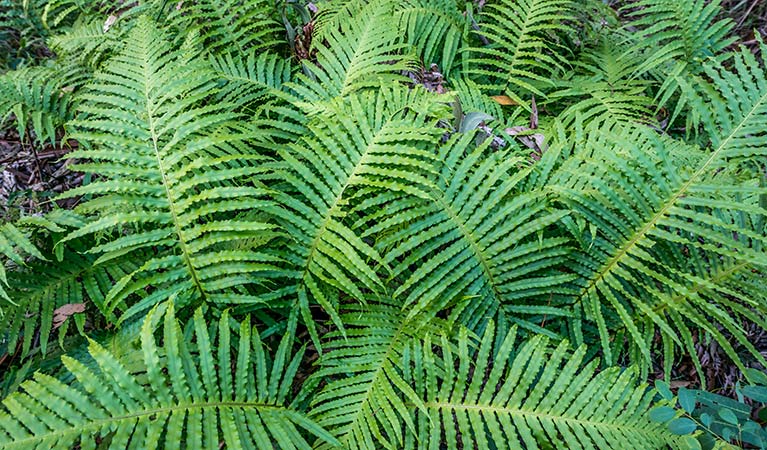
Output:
top-left (552, 116), bottom-right (767, 372)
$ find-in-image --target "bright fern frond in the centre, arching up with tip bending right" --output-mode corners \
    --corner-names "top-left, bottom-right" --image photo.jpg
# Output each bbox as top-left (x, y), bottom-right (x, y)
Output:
top-left (278, 88), bottom-right (450, 341)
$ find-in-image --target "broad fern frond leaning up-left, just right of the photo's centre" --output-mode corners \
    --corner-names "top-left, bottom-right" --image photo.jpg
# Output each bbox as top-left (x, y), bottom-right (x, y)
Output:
top-left (363, 129), bottom-right (571, 334)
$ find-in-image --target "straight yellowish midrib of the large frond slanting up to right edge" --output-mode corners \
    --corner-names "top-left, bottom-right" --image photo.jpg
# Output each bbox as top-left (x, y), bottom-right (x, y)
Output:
top-left (576, 88), bottom-right (767, 303)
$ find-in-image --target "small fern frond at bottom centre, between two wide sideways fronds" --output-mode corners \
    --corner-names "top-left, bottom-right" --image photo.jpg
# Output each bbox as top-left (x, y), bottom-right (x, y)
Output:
top-left (307, 297), bottom-right (446, 449)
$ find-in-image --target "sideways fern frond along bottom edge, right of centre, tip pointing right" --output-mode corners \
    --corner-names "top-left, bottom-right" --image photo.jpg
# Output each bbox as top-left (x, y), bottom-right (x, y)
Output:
top-left (403, 324), bottom-right (684, 449)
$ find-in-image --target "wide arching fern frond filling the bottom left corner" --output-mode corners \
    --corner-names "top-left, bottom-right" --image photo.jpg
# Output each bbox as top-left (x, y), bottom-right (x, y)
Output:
top-left (0, 305), bottom-right (336, 449)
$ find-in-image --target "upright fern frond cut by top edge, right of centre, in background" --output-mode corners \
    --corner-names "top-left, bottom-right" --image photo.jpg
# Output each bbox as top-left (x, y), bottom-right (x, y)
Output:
top-left (468, 0), bottom-right (572, 105)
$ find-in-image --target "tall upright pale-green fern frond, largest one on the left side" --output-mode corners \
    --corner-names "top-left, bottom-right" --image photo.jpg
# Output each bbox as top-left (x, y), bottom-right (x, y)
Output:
top-left (60, 17), bottom-right (284, 317)
